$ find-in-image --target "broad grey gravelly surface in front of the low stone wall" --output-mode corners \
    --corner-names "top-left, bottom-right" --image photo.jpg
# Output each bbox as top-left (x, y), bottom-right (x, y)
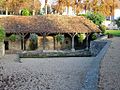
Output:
top-left (0, 55), bottom-right (94, 90)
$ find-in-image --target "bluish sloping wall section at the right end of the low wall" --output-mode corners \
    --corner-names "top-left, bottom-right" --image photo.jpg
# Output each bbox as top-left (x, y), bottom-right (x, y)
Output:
top-left (90, 40), bottom-right (107, 56)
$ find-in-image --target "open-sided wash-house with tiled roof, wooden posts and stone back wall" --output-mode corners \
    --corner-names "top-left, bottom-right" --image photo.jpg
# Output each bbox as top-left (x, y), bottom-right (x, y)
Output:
top-left (0, 15), bottom-right (100, 51)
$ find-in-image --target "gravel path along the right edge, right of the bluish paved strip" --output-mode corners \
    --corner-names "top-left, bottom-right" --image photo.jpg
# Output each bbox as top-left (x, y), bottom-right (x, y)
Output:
top-left (99, 37), bottom-right (120, 90)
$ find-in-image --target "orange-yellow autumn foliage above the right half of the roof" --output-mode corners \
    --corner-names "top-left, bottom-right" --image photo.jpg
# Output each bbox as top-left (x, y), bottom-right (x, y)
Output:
top-left (53, 0), bottom-right (120, 16)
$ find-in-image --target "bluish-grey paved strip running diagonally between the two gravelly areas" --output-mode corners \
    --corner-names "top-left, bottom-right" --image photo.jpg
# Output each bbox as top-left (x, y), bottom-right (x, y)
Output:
top-left (81, 40), bottom-right (111, 90)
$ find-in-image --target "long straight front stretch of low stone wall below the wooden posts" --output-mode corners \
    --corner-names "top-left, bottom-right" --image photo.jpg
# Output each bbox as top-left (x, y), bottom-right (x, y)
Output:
top-left (19, 50), bottom-right (91, 58)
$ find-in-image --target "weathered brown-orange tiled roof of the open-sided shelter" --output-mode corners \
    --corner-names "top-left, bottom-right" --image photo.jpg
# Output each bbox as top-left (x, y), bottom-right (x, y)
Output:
top-left (0, 15), bottom-right (100, 33)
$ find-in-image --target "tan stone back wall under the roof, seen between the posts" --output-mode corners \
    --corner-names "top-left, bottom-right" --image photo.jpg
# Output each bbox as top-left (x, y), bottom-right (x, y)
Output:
top-left (9, 36), bottom-right (72, 50)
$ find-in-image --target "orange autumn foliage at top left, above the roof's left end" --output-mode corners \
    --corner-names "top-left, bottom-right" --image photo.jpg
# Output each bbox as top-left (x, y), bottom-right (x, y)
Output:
top-left (0, 0), bottom-right (41, 14)
